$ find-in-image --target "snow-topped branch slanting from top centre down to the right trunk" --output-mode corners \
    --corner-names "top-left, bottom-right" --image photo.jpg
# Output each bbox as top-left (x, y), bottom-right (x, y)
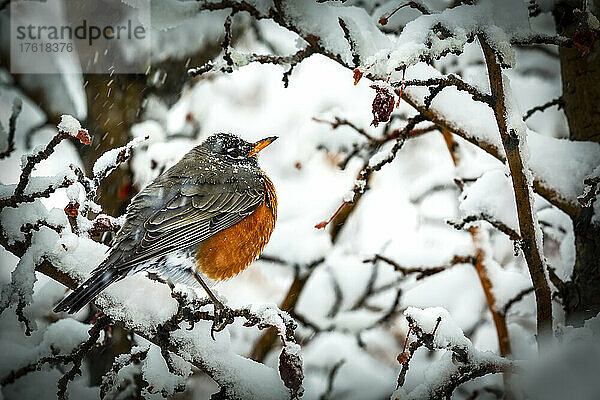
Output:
top-left (186, 0), bottom-right (596, 222)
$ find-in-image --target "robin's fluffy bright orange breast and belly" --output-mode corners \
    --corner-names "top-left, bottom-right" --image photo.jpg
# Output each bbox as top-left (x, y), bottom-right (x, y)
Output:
top-left (196, 177), bottom-right (277, 280)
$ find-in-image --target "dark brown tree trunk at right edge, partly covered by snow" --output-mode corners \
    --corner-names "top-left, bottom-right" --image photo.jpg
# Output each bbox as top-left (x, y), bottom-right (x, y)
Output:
top-left (554, 0), bottom-right (600, 326)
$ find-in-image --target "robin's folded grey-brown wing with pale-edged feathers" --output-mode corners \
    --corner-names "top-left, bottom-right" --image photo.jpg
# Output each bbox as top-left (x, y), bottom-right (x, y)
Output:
top-left (117, 184), bottom-right (265, 268)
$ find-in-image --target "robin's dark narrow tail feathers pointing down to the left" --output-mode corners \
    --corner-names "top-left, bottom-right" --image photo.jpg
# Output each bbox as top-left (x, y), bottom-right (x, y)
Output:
top-left (54, 268), bottom-right (124, 314)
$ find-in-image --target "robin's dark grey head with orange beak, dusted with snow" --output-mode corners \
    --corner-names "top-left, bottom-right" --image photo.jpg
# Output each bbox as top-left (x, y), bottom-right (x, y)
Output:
top-left (202, 133), bottom-right (277, 165)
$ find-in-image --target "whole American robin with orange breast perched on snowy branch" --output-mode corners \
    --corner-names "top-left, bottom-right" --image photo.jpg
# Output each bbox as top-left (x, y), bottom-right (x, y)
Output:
top-left (54, 133), bottom-right (277, 315)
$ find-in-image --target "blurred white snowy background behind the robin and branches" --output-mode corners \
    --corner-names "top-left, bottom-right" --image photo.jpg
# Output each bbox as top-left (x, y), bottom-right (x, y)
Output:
top-left (0, 1), bottom-right (600, 399)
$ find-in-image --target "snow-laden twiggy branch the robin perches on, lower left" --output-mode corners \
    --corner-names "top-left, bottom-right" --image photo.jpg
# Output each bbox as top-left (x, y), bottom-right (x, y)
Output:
top-left (0, 116), bottom-right (303, 399)
